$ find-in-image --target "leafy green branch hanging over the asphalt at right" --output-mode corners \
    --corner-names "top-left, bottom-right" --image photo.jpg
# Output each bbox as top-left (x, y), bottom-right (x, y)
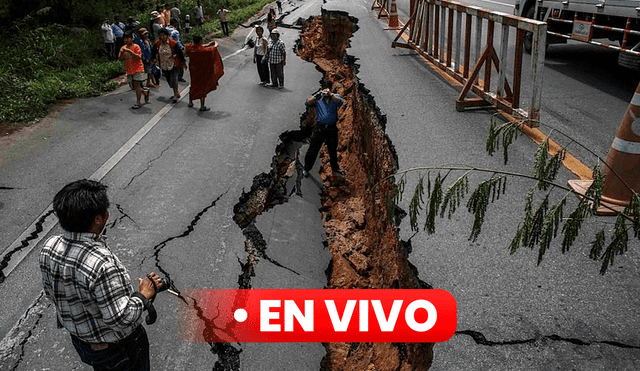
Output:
top-left (387, 120), bottom-right (640, 274)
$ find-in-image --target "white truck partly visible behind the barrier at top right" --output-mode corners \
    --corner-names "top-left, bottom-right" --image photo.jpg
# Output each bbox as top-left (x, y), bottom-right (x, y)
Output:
top-left (513, 0), bottom-right (640, 71)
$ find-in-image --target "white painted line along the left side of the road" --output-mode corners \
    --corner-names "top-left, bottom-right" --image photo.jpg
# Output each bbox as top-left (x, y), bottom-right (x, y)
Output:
top-left (0, 46), bottom-right (248, 279)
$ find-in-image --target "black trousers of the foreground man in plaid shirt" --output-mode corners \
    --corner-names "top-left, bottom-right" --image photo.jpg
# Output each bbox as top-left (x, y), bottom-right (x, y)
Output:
top-left (71, 325), bottom-right (150, 371)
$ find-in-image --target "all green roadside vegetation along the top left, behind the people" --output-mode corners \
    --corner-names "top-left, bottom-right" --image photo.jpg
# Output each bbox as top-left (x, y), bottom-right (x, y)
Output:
top-left (0, 0), bottom-right (270, 124)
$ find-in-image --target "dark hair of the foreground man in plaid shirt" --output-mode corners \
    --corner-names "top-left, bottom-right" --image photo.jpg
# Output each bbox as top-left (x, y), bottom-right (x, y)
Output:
top-left (53, 179), bottom-right (109, 232)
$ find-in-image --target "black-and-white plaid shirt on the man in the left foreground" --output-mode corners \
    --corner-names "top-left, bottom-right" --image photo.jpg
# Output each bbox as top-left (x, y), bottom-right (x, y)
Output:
top-left (40, 232), bottom-right (144, 343)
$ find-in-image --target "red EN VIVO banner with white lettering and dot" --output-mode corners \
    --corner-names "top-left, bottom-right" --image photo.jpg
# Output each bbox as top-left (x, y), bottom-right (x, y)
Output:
top-left (180, 290), bottom-right (457, 343)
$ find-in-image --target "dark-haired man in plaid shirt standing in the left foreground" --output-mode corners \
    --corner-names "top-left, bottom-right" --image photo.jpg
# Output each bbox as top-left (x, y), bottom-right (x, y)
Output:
top-left (39, 179), bottom-right (162, 371)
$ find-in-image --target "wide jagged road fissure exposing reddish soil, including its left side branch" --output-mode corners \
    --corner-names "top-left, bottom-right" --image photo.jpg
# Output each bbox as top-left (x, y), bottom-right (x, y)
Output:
top-left (234, 10), bottom-right (433, 371)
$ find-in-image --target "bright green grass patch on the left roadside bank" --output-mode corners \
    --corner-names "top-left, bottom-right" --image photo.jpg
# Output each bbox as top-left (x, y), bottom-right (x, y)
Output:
top-left (0, 25), bottom-right (123, 123)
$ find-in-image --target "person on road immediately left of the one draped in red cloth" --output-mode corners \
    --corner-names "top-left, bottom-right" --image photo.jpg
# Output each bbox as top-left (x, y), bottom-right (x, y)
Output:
top-left (151, 28), bottom-right (187, 103)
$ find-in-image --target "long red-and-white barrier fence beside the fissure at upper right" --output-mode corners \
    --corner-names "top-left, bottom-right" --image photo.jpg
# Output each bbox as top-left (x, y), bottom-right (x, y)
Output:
top-left (372, 0), bottom-right (547, 126)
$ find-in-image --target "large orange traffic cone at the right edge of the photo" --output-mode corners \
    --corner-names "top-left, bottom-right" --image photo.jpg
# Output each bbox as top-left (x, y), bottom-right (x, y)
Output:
top-left (569, 84), bottom-right (640, 215)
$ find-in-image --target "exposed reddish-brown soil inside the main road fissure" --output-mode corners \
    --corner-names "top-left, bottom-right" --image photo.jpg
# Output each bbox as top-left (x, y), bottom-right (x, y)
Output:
top-left (297, 10), bottom-right (433, 371)
